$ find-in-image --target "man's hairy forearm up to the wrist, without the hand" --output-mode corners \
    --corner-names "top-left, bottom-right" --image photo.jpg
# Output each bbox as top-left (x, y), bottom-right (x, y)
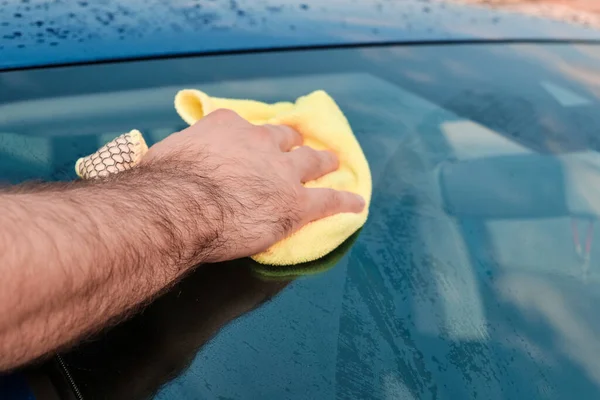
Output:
top-left (0, 164), bottom-right (218, 370)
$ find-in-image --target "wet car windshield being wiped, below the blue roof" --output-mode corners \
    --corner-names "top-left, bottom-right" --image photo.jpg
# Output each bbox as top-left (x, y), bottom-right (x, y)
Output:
top-left (0, 44), bottom-right (600, 400)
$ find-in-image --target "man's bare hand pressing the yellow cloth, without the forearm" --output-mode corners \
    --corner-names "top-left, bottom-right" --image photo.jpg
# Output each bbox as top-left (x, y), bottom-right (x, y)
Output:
top-left (141, 110), bottom-right (364, 262)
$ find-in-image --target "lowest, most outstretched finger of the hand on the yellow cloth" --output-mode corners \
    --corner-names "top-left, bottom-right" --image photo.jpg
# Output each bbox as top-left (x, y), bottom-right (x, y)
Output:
top-left (306, 188), bottom-right (365, 221)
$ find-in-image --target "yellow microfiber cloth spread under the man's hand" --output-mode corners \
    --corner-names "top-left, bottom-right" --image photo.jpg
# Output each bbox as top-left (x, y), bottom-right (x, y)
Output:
top-left (76, 90), bottom-right (371, 265)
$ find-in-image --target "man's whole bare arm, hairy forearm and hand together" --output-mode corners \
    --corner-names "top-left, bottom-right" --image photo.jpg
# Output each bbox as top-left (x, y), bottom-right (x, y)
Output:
top-left (0, 110), bottom-right (364, 370)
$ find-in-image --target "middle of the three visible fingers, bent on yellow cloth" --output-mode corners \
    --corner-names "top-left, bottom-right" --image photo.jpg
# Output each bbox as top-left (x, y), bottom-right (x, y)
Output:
top-left (288, 146), bottom-right (339, 183)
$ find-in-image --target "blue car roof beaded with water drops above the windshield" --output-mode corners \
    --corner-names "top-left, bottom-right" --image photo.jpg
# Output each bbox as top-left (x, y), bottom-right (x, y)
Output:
top-left (0, 0), bottom-right (600, 69)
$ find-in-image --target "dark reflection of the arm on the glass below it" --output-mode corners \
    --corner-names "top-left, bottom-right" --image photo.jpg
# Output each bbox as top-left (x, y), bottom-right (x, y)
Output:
top-left (58, 259), bottom-right (290, 400)
